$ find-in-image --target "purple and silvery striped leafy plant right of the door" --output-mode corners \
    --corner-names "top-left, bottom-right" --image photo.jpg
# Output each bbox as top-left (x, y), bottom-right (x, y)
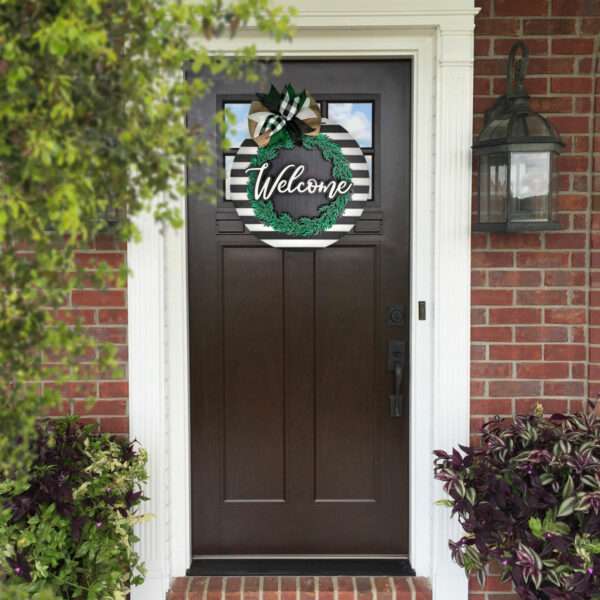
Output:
top-left (435, 414), bottom-right (600, 600)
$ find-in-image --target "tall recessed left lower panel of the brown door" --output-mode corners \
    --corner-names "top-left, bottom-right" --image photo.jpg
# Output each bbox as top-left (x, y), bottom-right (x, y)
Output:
top-left (223, 248), bottom-right (285, 502)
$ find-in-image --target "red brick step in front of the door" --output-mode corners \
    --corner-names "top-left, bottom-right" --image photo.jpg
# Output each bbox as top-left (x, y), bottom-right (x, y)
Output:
top-left (167, 576), bottom-right (431, 600)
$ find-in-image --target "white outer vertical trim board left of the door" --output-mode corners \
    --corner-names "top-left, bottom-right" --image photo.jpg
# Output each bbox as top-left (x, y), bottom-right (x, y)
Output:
top-left (127, 209), bottom-right (173, 600)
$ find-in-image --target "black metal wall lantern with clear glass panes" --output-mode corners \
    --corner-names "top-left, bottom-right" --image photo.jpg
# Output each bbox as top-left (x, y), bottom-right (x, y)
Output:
top-left (473, 42), bottom-right (564, 231)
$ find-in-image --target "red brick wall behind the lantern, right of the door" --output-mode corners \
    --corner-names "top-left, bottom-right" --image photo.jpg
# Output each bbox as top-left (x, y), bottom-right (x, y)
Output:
top-left (471, 0), bottom-right (600, 600)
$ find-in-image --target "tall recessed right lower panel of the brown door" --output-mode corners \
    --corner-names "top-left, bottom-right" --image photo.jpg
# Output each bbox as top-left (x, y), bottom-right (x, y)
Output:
top-left (315, 246), bottom-right (378, 502)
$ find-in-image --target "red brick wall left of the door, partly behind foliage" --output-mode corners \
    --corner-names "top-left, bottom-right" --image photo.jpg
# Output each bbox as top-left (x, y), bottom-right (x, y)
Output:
top-left (44, 236), bottom-right (129, 434)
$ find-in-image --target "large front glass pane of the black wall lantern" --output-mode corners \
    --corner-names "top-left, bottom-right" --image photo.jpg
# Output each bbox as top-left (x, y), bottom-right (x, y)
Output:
top-left (510, 152), bottom-right (551, 221)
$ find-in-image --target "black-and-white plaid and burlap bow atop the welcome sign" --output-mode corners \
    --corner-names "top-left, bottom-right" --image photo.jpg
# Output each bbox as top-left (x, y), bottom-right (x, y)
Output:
top-left (248, 84), bottom-right (321, 146)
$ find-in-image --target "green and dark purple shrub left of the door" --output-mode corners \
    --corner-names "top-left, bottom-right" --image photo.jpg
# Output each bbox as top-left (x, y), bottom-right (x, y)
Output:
top-left (0, 418), bottom-right (147, 600)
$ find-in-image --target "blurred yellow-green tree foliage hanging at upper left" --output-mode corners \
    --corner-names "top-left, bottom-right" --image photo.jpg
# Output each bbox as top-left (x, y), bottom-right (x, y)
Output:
top-left (0, 0), bottom-right (292, 477)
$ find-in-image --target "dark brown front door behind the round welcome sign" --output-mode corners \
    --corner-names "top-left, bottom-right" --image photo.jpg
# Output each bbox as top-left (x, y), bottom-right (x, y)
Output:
top-left (188, 60), bottom-right (411, 555)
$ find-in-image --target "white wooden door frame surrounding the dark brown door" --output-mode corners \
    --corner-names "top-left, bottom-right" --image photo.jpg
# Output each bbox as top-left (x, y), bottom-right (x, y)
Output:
top-left (128, 0), bottom-right (476, 600)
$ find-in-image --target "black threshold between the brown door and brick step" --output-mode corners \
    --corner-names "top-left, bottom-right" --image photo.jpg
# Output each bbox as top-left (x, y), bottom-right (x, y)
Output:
top-left (187, 557), bottom-right (415, 577)
